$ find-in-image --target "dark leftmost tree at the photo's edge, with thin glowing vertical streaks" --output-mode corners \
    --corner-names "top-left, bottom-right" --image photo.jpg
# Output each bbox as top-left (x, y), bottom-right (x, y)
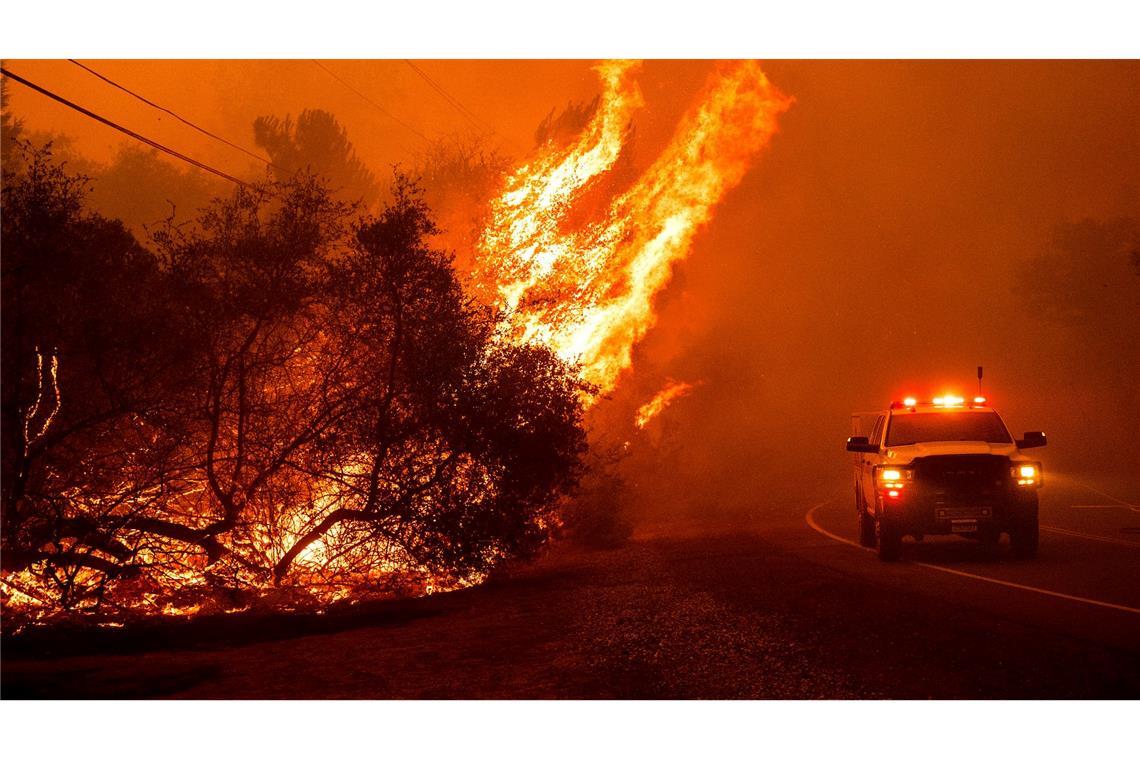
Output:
top-left (0, 141), bottom-right (193, 605)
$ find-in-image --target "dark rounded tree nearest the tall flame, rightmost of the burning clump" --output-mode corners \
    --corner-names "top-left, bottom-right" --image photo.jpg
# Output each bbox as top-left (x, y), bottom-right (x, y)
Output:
top-left (275, 178), bottom-right (585, 579)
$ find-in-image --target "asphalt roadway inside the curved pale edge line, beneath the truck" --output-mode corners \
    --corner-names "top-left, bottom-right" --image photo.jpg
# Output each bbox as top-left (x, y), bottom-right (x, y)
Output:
top-left (805, 476), bottom-right (1140, 648)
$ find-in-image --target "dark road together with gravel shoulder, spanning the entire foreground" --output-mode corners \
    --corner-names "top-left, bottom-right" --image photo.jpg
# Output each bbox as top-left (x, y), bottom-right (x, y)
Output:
top-left (2, 476), bottom-right (1140, 698)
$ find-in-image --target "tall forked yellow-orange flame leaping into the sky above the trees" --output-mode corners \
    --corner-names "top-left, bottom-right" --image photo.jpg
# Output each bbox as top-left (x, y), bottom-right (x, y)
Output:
top-left (475, 62), bottom-right (791, 393)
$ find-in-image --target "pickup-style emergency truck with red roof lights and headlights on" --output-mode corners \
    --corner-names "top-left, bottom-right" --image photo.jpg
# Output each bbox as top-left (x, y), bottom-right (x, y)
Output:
top-left (847, 394), bottom-right (1045, 562)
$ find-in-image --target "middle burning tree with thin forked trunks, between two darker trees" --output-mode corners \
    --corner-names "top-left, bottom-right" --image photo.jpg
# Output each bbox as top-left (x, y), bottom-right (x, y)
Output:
top-left (145, 175), bottom-right (352, 583)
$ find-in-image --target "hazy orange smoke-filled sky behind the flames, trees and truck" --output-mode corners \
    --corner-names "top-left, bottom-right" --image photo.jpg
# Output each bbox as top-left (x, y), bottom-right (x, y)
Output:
top-left (6, 60), bottom-right (1140, 519)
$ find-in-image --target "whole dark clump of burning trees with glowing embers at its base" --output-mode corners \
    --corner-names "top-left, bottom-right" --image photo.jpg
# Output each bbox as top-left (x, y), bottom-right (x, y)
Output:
top-left (2, 146), bottom-right (585, 624)
